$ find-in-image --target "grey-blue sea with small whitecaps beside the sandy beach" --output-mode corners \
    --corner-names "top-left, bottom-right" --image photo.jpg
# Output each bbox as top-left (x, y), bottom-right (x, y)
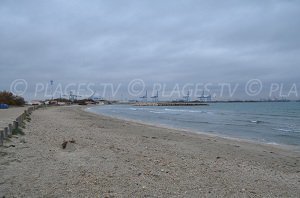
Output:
top-left (87, 102), bottom-right (300, 148)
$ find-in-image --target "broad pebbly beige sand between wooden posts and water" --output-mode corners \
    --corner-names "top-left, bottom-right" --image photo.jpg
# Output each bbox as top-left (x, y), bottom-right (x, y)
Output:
top-left (0, 107), bottom-right (300, 197)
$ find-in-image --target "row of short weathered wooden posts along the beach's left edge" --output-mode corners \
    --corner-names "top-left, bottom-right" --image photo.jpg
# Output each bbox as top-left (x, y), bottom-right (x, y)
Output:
top-left (0, 106), bottom-right (38, 146)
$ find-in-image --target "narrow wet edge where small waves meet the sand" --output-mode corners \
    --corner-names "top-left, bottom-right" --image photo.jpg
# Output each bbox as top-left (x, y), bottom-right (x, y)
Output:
top-left (82, 106), bottom-right (300, 153)
